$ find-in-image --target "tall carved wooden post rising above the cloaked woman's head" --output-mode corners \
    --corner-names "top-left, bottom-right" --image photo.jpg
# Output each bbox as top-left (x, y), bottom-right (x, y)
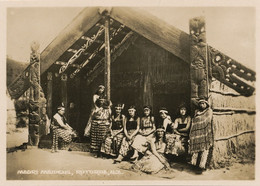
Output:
top-left (190, 17), bottom-right (208, 103)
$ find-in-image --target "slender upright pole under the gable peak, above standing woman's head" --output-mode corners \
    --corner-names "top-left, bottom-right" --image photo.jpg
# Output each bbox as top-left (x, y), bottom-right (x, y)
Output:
top-left (105, 16), bottom-right (111, 100)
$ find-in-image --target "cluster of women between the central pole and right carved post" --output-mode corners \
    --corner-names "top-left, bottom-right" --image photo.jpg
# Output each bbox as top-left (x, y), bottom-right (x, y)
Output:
top-left (85, 85), bottom-right (212, 173)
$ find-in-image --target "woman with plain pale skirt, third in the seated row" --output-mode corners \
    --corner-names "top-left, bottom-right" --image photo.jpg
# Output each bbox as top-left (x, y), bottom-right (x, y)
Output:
top-left (131, 106), bottom-right (156, 159)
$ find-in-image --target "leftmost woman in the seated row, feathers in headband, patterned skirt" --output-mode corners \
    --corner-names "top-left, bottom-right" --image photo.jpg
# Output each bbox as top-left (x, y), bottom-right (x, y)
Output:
top-left (101, 104), bottom-right (125, 156)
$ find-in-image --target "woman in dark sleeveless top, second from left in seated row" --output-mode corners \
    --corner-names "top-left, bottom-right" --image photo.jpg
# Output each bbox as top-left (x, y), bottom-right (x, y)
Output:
top-left (114, 106), bottom-right (140, 163)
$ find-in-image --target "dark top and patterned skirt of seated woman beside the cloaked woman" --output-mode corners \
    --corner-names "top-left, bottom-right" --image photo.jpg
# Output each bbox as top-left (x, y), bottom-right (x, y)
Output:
top-left (166, 116), bottom-right (191, 156)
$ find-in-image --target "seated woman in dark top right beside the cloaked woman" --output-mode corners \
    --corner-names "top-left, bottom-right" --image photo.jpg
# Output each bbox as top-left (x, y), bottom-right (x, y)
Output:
top-left (166, 104), bottom-right (191, 156)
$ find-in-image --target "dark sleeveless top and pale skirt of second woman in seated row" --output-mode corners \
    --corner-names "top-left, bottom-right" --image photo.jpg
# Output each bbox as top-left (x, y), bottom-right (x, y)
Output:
top-left (119, 117), bottom-right (139, 157)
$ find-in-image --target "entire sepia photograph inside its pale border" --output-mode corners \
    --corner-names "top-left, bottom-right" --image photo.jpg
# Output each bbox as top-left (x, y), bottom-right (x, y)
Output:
top-left (3, 6), bottom-right (256, 183)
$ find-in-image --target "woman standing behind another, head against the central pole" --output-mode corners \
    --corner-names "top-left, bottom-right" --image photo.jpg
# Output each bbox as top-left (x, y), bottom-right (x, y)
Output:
top-left (84, 85), bottom-right (105, 136)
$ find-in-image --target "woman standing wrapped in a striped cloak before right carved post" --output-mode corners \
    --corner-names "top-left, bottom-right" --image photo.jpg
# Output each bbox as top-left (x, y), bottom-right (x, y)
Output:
top-left (189, 99), bottom-right (214, 173)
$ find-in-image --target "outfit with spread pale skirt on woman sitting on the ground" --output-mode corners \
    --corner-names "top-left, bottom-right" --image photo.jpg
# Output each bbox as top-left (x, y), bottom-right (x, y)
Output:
top-left (133, 140), bottom-right (167, 174)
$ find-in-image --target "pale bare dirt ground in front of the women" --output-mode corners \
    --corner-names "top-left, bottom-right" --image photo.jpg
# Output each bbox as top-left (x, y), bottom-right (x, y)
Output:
top-left (7, 148), bottom-right (255, 180)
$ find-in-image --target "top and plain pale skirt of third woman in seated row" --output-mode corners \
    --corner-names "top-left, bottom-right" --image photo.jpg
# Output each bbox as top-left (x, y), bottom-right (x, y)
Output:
top-left (131, 116), bottom-right (155, 153)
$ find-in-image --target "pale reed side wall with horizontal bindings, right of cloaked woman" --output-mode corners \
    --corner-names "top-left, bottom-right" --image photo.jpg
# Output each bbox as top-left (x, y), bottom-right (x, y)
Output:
top-left (210, 81), bottom-right (255, 168)
